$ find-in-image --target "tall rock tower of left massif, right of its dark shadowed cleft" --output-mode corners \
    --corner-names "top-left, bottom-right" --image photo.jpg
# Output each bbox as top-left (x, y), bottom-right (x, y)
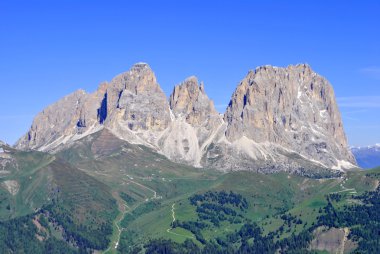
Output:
top-left (106, 63), bottom-right (171, 131)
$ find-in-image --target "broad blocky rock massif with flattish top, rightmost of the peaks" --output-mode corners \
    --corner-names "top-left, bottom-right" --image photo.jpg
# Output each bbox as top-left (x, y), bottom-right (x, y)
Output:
top-left (224, 64), bottom-right (356, 167)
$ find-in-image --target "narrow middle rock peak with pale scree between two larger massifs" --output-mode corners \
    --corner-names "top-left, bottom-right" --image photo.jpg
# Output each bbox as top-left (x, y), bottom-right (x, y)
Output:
top-left (159, 77), bottom-right (223, 166)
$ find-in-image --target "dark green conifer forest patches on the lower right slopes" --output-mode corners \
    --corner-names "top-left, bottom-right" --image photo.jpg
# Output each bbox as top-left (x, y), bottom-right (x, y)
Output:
top-left (135, 187), bottom-right (380, 254)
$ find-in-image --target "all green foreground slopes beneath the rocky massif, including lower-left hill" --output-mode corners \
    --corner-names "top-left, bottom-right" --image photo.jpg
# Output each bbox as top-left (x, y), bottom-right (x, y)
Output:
top-left (0, 130), bottom-right (380, 253)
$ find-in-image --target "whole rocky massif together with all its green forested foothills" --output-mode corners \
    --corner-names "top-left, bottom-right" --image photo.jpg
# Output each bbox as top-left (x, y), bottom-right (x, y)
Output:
top-left (0, 63), bottom-right (380, 254)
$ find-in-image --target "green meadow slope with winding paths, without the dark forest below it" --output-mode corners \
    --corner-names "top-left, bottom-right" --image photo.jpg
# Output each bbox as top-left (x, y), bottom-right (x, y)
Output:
top-left (54, 130), bottom-right (377, 253)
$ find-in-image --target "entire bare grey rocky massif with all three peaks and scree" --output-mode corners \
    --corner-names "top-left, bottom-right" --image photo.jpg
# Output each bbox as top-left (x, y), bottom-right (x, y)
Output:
top-left (16, 63), bottom-right (356, 172)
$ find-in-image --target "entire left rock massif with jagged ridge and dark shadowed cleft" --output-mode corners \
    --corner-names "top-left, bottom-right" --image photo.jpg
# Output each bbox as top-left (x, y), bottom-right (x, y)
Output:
top-left (16, 63), bottom-right (171, 151)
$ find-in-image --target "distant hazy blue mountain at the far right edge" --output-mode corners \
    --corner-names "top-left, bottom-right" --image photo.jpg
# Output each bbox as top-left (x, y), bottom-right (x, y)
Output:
top-left (351, 144), bottom-right (380, 169)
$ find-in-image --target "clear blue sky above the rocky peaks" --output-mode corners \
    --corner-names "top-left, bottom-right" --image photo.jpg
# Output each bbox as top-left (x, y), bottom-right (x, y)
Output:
top-left (0, 0), bottom-right (380, 145)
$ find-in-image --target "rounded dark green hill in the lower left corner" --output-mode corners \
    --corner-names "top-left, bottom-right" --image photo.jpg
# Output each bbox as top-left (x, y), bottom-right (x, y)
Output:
top-left (0, 143), bottom-right (117, 250)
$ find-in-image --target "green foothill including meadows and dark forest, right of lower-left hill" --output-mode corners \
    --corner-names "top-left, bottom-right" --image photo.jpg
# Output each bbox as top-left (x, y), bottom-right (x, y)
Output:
top-left (34, 128), bottom-right (380, 253)
